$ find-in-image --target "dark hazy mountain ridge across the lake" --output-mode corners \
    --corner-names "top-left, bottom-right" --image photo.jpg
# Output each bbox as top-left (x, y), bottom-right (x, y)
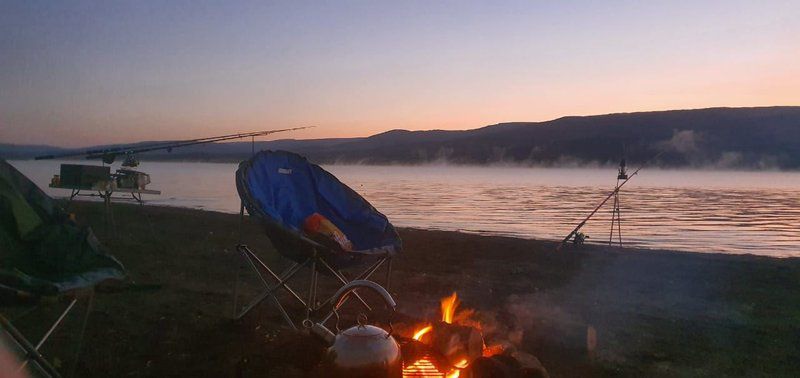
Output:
top-left (0, 106), bottom-right (800, 169)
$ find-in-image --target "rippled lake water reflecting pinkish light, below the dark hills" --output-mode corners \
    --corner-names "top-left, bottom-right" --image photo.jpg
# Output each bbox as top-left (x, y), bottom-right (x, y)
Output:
top-left (11, 161), bottom-right (800, 257)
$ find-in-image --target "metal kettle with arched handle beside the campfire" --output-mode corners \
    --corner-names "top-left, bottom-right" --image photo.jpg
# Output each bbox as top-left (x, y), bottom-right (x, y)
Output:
top-left (311, 280), bottom-right (403, 378)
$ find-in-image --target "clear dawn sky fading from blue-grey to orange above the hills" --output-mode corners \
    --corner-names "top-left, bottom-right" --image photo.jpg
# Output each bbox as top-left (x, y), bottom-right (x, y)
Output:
top-left (0, 0), bottom-right (800, 147)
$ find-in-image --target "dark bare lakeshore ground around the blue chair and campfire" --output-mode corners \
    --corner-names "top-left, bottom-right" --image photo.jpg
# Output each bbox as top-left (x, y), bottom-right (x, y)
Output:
top-left (7, 202), bottom-right (800, 377)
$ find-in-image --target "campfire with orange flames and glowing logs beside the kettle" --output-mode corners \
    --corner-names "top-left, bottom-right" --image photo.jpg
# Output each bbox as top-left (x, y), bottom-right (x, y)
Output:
top-left (403, 293), bottom-right (503, 378)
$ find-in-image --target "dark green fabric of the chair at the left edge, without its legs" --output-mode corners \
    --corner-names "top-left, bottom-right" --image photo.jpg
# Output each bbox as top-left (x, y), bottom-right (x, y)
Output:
top-left (0, 159), bottom-right (125, 295)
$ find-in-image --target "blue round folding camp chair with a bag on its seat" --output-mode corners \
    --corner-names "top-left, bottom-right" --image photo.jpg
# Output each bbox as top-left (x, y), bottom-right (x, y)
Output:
top-left (234, 151), bottom-right (402, 329)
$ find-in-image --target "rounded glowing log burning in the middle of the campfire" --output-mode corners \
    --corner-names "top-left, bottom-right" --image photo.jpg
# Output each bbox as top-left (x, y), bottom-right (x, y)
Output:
top-left (430, 322), bottom-right (483, 368)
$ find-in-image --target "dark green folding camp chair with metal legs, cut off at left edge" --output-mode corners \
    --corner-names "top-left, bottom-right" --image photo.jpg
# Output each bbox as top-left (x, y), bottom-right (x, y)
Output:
top-left (0, 159), bottom-right (125, 377)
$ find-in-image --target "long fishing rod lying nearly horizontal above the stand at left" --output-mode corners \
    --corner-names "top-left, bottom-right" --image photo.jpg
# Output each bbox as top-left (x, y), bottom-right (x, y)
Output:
top-left (34, 126), bottom-right (314, 162)
